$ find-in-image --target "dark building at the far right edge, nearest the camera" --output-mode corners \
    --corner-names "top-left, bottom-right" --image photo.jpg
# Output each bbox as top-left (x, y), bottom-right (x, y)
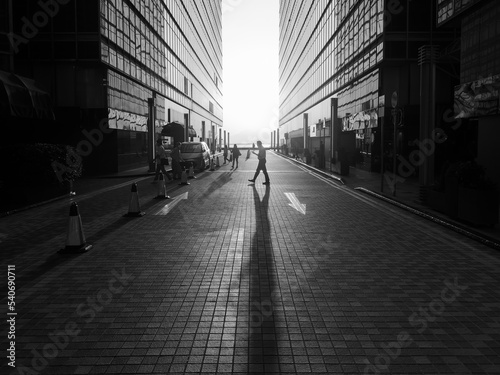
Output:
top-left (437, 0), bottom-right (500, 186)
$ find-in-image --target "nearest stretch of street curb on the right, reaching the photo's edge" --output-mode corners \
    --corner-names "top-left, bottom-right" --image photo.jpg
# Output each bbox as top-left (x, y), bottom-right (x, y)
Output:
top-left (354, 187), bottom-right (500, 250)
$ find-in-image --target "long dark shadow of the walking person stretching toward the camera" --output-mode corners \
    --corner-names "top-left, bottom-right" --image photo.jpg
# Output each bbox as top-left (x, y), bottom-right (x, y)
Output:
top-left (248, 185), bottom-right (279, 373)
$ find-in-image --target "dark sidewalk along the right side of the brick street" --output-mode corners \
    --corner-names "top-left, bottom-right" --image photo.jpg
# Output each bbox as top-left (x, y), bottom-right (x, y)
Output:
top-left (277, 153), bottom-right (500, 249)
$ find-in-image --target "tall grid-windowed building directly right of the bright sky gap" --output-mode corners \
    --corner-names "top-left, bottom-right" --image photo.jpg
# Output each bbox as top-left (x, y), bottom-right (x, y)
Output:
top-left (278, 0), bottom-right (458, 182)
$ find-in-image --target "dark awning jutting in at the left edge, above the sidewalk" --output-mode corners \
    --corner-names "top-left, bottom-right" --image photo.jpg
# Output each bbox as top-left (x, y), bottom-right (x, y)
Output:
top-left (0, 71), bottom-right (54, 119)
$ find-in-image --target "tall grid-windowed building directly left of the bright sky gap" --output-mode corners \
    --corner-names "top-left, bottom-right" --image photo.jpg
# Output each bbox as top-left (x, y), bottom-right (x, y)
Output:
top-left (0, 0), bottom-right (222, 172)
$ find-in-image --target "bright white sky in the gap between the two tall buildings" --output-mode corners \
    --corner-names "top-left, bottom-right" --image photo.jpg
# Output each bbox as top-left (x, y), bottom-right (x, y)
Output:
top-left (222, 0), bottom-right (279, 146)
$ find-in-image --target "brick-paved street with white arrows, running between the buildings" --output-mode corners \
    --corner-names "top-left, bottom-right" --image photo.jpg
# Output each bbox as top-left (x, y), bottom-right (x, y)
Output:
top-left (0, 152), bottom-right (500, 375)
